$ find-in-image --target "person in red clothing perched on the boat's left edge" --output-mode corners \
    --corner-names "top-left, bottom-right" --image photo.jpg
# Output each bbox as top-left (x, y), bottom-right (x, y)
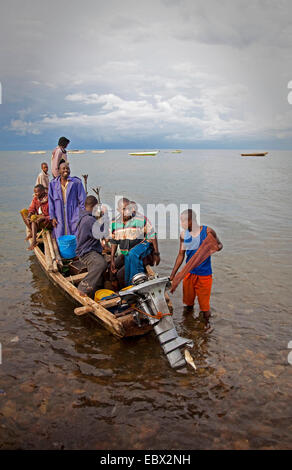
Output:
top-left (21, 184), bottom-right (50, 250)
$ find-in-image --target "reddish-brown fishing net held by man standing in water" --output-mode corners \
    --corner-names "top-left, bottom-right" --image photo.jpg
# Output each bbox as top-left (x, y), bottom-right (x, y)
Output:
top-left (170, 232), bottom-right (219, 293)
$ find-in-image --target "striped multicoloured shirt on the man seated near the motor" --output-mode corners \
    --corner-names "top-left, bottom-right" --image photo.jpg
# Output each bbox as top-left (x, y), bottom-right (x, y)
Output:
top-left (110, 213), bottom-right (156, 254)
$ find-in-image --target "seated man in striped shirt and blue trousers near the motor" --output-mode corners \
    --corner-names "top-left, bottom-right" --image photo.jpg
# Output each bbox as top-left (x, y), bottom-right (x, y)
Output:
top-left (111, 198), bottom-right (160, 286)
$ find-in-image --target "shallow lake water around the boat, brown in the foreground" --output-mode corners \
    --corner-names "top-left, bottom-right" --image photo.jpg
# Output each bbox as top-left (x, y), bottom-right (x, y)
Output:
top-left (0, 150), bottom-right (292, 449)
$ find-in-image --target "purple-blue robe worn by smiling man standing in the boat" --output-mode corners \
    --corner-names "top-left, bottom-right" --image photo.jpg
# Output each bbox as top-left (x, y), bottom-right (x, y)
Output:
top-left (49, 176), bottom-right (86, 239)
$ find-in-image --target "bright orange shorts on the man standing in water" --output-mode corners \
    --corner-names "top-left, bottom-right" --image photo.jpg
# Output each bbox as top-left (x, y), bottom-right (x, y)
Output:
top-left (183, 273), bottom-right (212, 312)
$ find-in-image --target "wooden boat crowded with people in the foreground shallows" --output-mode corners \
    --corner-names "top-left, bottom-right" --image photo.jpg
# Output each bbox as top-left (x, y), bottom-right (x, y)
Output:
top-left (24, 230), bottom-right (159, 338)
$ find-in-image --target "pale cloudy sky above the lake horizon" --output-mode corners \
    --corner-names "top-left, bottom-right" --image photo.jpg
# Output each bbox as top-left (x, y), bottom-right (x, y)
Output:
top-left (0, 0), bottom-right (292, 149)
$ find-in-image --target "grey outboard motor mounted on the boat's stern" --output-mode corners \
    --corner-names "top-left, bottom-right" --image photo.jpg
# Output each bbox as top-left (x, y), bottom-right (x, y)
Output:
top-left (119, 273), bottom-right (193, 368)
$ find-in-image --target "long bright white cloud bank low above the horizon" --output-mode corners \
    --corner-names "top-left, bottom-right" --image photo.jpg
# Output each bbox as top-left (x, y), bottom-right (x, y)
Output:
top-left (10, 84), bottom-right (292, 142)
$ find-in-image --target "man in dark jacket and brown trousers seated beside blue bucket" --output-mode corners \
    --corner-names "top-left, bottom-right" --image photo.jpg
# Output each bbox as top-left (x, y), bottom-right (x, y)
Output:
top-left (76, 196), bottom-right (108, 297)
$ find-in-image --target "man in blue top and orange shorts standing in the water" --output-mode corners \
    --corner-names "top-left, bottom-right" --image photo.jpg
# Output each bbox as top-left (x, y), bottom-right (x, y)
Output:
top-left (170, 209), bottom-right (223, 320)
